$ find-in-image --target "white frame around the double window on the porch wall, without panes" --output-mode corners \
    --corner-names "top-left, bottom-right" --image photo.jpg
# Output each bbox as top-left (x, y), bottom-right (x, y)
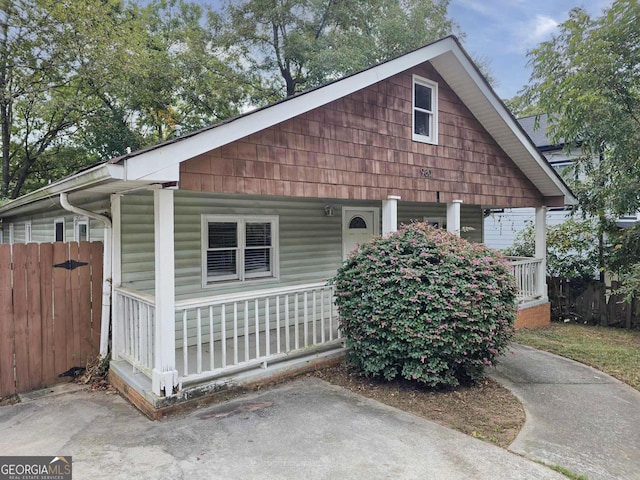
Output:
top-left (200, 214), bottom-right (280, 287)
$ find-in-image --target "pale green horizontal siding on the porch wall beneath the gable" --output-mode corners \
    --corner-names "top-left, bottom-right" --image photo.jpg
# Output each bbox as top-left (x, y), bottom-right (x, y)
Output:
top-left (117, 190), bottom-right (482, 300)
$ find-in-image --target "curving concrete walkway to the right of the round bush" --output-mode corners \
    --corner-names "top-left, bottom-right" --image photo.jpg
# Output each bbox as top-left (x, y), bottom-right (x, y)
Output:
top-left (491, 345), bottom-right (640, 480)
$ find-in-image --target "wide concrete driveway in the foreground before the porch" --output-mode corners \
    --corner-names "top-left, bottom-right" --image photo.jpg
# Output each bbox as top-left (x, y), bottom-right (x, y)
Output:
top-left (0, 378), bottom-right (566, 480)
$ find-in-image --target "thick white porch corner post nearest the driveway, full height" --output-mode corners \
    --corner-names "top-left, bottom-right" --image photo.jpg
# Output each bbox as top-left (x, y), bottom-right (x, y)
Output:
top-left (151, 188), bottom-right (178, 396)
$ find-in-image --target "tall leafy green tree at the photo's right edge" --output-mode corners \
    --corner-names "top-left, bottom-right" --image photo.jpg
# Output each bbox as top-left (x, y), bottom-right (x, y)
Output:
top-left (523, 0), bottom-right (640, 288)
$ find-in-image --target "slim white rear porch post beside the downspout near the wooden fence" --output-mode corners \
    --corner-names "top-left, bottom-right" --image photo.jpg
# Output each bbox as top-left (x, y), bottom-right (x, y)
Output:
top-left (111, 195), bottom-right (124, 360)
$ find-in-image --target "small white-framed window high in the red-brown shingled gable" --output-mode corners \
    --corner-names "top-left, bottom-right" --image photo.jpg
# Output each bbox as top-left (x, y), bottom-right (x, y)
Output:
top-left (413, 75), bottom-right (438, 145)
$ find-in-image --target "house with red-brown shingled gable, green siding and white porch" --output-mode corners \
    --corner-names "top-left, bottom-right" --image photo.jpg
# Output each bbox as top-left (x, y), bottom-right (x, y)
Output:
top-left (0, 36), bottom-right (575, 409)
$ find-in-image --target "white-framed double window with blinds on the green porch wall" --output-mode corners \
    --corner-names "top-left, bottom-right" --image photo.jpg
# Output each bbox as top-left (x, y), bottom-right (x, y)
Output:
top-left (202, 215), bottom-right (278, 285)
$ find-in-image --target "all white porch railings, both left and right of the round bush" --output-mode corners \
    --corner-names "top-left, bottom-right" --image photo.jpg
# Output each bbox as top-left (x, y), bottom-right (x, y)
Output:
top-left (112, 251), bottom-right (547, 407)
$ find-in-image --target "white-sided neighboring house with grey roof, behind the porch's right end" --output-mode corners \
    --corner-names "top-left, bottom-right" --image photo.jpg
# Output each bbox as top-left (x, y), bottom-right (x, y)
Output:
top-left (484, 114), bottom-right (580, 250)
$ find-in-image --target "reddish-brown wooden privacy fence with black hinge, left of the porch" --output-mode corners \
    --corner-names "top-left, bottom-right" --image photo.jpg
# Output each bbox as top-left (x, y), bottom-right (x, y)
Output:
top-left (0, 242), bottom-right (102, 397)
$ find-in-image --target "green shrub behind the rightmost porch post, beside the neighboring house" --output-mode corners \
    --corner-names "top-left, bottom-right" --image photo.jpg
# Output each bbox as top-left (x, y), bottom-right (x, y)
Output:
top-left (503, 217), bottom-right (598, 280)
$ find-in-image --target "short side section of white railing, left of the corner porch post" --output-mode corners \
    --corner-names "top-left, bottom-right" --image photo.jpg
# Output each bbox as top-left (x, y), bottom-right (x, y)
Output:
top-left (113, 287), bottom-right (155, 378)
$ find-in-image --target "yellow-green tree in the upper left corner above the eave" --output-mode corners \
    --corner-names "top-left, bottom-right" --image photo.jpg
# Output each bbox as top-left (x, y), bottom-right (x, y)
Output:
top-left (0, 0), bottom-right (146, 198)
